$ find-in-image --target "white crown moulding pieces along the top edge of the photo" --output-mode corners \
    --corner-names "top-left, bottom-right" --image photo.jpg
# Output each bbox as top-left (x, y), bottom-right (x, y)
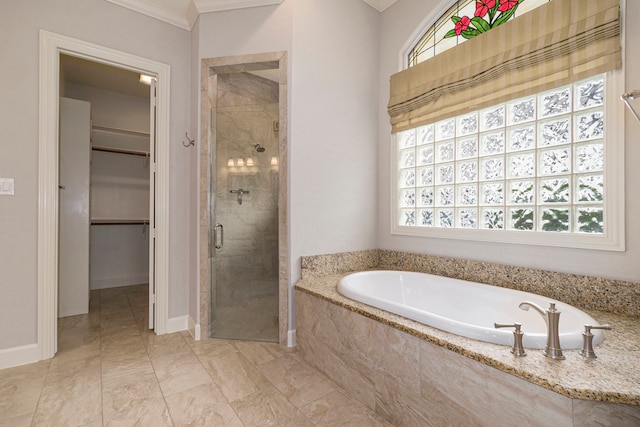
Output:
top-left (107, 0), bottom-right (398, 30)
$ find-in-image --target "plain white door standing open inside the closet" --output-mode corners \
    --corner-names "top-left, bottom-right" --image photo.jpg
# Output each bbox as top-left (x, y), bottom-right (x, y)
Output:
top-left (58, 98), bottom-right (91, 317)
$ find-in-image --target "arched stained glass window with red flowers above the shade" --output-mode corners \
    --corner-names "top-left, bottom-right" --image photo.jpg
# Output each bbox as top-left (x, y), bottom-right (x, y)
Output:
top-left (407, 0), bottom-right (549, 67)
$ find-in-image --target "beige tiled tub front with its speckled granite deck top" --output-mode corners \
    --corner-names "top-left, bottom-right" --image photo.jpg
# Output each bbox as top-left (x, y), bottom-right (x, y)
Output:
top-left (296, 282), bottom-right (640, 426)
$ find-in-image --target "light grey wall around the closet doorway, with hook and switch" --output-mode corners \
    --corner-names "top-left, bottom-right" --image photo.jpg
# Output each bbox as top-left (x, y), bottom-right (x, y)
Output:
top-left (0, 0), bottom-right (191, 349)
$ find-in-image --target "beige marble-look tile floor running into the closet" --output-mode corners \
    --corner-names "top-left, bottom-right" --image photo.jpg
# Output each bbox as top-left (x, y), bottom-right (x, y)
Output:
top-left (0, 286), bottom-right (391, 427)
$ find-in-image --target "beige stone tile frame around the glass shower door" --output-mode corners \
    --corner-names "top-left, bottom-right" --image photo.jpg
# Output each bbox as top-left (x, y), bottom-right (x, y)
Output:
top-left (199, 52), bottom-right (289, 345)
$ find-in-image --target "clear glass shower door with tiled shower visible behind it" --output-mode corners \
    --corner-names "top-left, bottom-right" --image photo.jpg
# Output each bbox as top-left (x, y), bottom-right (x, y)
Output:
top-left (209, 68), bottom-right (280, 342)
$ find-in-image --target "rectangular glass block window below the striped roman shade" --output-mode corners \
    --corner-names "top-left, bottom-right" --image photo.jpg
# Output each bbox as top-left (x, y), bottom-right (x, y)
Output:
top-left (396, 75), bottom-right (607, 234)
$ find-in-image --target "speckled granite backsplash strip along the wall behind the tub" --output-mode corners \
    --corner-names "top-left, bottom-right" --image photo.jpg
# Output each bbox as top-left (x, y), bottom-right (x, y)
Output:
top-left (301, 249), bottom-right (640, 317)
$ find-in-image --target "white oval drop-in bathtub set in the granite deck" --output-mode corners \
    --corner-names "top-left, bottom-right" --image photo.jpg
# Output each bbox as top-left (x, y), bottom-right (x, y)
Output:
top-left (338, 271), bottom-right (604, 350)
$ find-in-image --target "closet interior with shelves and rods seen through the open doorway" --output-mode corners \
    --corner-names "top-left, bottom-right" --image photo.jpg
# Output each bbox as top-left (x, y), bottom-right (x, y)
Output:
top-left (58, 55), bottom-right (155, 332)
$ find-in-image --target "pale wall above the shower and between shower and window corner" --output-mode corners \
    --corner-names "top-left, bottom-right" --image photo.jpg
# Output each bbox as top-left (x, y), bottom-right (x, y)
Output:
top-left (199, 0), bottom-right (379, 336)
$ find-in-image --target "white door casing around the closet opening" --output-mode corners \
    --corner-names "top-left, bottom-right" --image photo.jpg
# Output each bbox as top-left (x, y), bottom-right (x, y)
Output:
top-left (38, 30), bottom-right (170, 360)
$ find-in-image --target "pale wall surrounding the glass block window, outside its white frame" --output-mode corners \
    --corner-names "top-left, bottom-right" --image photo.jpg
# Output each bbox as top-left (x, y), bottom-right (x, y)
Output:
top-left (378, 0), bottom-right (640, 281)
